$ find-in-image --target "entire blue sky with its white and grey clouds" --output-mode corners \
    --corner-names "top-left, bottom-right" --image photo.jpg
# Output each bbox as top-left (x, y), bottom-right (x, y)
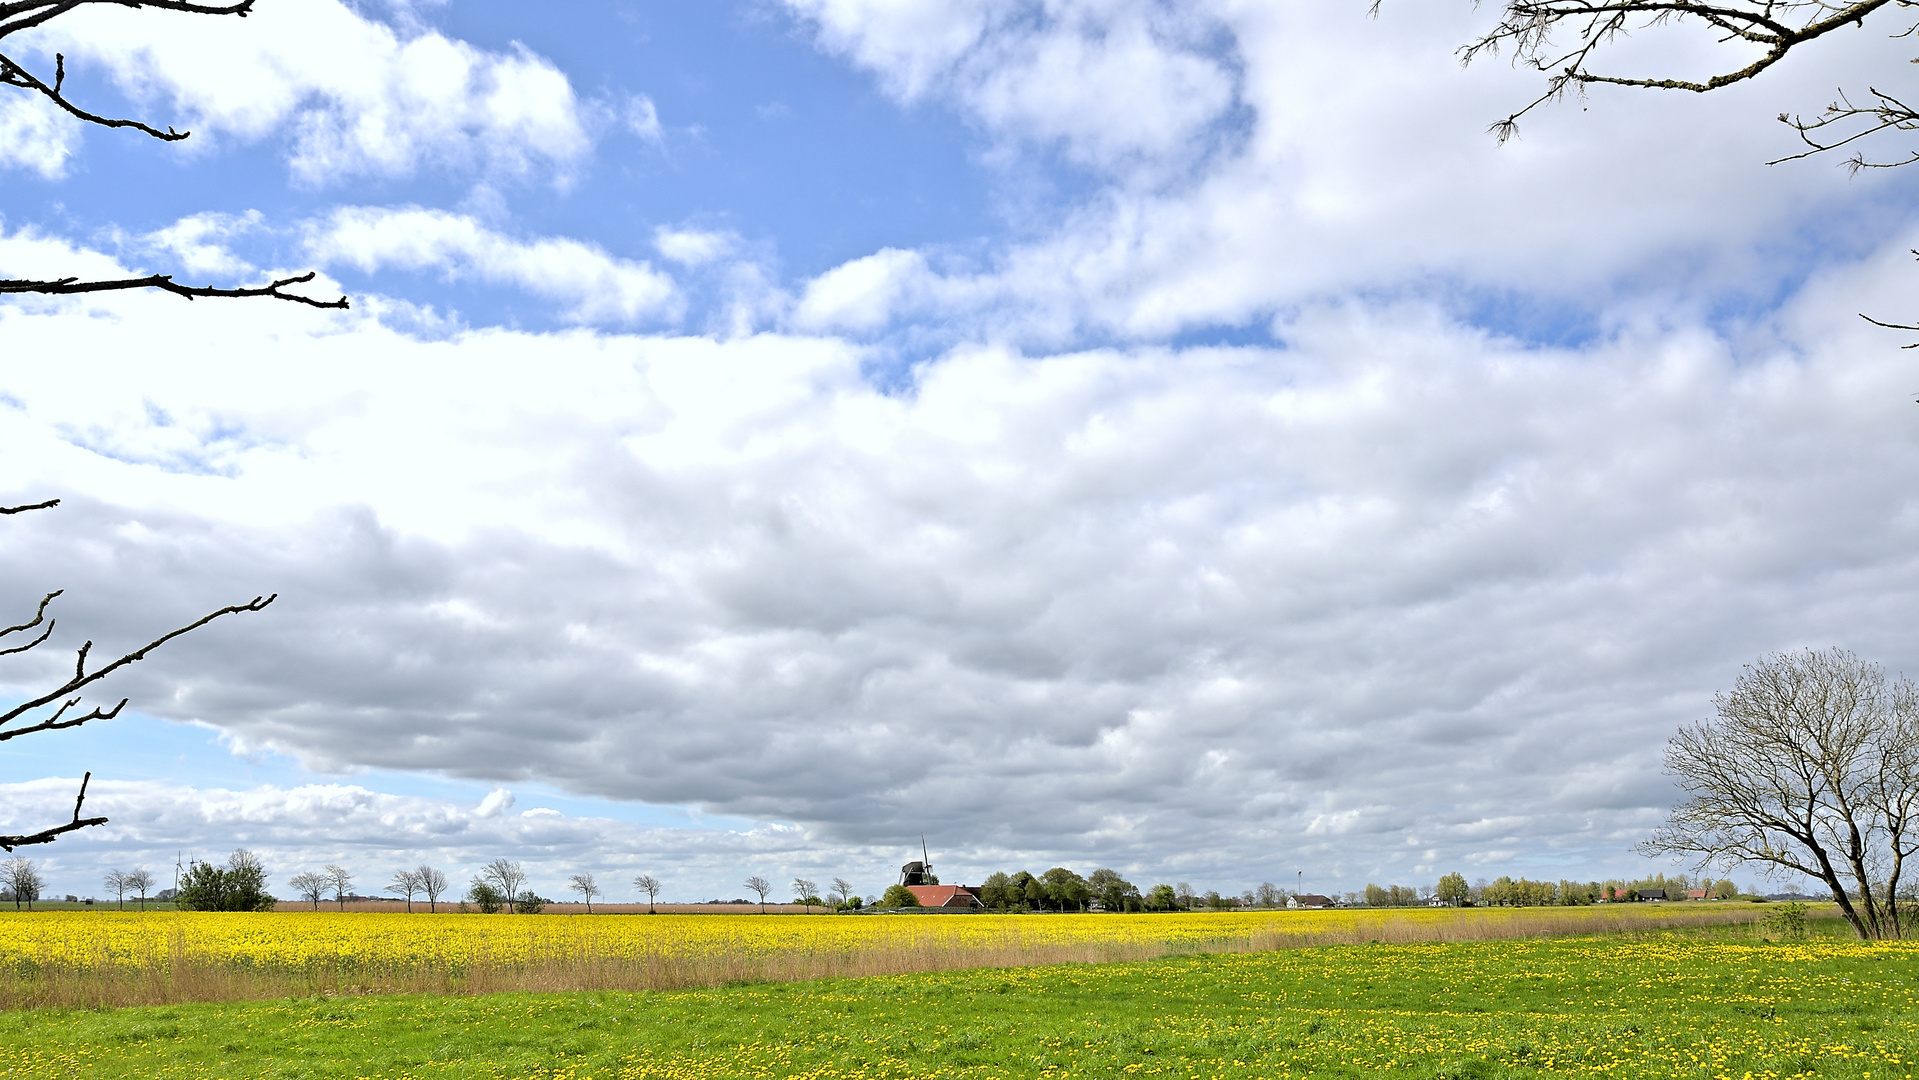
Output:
top-left (0, 0), bottom-right (1919, 900)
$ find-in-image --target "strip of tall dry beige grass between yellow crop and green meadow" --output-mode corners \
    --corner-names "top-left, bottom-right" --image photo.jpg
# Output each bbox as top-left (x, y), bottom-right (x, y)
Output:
top-left (0, 905), bottom-right (1764, 1009)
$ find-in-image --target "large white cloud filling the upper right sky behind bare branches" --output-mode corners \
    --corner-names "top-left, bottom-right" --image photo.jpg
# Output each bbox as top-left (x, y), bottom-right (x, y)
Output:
top-left (789, 0), bottom-right (1909, 347)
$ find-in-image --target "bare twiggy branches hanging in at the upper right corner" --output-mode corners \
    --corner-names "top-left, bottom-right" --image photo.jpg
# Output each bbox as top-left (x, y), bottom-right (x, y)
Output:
top-left (1443, 0), bottom-right (1919, 337)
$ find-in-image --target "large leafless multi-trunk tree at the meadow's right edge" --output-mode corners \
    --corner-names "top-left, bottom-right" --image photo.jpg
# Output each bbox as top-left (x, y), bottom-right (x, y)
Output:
top-left (1641, 648), bottom-right (1919, 938)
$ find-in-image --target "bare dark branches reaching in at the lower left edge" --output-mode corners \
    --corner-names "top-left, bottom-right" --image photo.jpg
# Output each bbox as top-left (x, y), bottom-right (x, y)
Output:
top-left (0, 498), bottom-right (278, 852)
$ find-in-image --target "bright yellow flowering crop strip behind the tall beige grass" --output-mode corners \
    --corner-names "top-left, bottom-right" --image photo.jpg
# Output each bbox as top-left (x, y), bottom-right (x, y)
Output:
top-left (0, 905), bottom-right (1750, 984)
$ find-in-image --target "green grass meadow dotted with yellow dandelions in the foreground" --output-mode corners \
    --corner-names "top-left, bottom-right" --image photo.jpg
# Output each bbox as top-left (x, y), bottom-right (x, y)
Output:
top-left (0, 928), bottom-right (1919, 1080)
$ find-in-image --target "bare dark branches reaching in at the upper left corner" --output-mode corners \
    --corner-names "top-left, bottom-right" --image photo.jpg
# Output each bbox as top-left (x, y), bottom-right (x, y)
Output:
top-left (0, 0), bottom-right (347, 309)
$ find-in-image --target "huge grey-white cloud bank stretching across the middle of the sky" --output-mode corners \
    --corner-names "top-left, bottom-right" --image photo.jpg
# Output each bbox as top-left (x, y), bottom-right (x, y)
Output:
top-left (0, 228), bottom-right (1919, 884)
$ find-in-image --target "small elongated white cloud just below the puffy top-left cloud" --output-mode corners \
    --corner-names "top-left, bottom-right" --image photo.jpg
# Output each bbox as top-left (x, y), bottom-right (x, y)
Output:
top-left (307, 207), bottom-right (679, 322)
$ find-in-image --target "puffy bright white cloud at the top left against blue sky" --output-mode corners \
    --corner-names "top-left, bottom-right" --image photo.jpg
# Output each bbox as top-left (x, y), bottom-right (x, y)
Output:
top-left (23, 0), bottom-right (591, 184)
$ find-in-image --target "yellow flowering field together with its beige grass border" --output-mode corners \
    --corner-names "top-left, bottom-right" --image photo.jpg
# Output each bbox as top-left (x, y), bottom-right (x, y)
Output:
top-left (0, 904), bottom-right (1765, 1009)
